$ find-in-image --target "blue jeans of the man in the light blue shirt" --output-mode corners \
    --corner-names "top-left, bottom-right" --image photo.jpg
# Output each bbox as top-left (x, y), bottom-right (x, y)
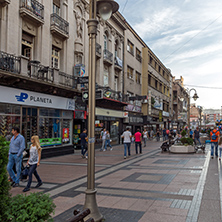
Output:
top-left (7, 154), bottom-right (22, 183)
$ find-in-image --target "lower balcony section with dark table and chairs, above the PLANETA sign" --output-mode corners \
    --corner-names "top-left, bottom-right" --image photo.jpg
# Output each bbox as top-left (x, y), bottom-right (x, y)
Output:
top-left (28, 60), bottom-right (54, 83)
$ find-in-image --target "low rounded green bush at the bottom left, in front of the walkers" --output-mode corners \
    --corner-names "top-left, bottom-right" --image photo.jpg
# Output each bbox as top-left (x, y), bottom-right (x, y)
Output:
top-left (8, 193), bottom-right (56, 222)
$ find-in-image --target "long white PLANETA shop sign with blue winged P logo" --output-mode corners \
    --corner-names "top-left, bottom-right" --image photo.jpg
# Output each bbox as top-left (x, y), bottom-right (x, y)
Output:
top-left (0, 86), bottom-right (75, 110)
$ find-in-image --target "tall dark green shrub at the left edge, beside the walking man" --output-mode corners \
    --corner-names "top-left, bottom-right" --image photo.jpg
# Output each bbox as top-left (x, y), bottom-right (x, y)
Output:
top-left (0, 136), bottom-right (10, 221)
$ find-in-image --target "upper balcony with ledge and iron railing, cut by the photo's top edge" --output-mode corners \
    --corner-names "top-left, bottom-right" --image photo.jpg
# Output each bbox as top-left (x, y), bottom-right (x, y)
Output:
top-left (19, 0), bottom-right (44, 26)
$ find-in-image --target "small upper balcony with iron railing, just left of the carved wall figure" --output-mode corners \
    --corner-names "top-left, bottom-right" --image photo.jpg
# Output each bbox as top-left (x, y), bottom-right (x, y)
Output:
top-left (50, 13), bottom-right (69, 39)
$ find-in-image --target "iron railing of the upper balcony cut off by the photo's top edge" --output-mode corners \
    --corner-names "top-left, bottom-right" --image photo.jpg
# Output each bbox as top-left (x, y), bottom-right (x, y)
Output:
top-left (20, 0), bottom-right (44, 19)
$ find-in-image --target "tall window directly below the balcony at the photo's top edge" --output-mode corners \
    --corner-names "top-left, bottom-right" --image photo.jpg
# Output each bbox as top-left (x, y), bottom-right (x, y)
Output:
top-left (22, 32), bottom-right (33, 60)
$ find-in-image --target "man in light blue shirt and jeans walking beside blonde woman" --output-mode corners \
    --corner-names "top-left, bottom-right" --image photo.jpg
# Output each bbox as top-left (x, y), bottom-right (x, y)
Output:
top-left (7, 127), bottom-right (25, 187)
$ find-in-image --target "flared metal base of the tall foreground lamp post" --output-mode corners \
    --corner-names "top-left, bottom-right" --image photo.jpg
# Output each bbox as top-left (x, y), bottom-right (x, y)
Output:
top-left (84, 189), bottom-right (104, 222)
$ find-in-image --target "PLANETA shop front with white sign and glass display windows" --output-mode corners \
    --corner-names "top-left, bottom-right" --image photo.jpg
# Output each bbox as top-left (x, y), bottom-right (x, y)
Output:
top-left (0, 86), bottom-right (75, 157)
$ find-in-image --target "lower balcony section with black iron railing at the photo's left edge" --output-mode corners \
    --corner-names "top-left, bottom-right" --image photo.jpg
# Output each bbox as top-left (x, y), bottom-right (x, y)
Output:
top-left (0, 51), bottom-right (21, 74)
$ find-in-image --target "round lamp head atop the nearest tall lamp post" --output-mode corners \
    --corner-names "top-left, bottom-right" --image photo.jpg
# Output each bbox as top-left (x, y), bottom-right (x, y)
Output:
top-left (97, 0), bottom-right (119, 21)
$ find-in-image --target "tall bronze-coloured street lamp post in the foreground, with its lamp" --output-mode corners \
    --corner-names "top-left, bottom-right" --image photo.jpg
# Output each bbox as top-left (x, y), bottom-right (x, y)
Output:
top-left (84, 0), bottom-right (119, 221)
